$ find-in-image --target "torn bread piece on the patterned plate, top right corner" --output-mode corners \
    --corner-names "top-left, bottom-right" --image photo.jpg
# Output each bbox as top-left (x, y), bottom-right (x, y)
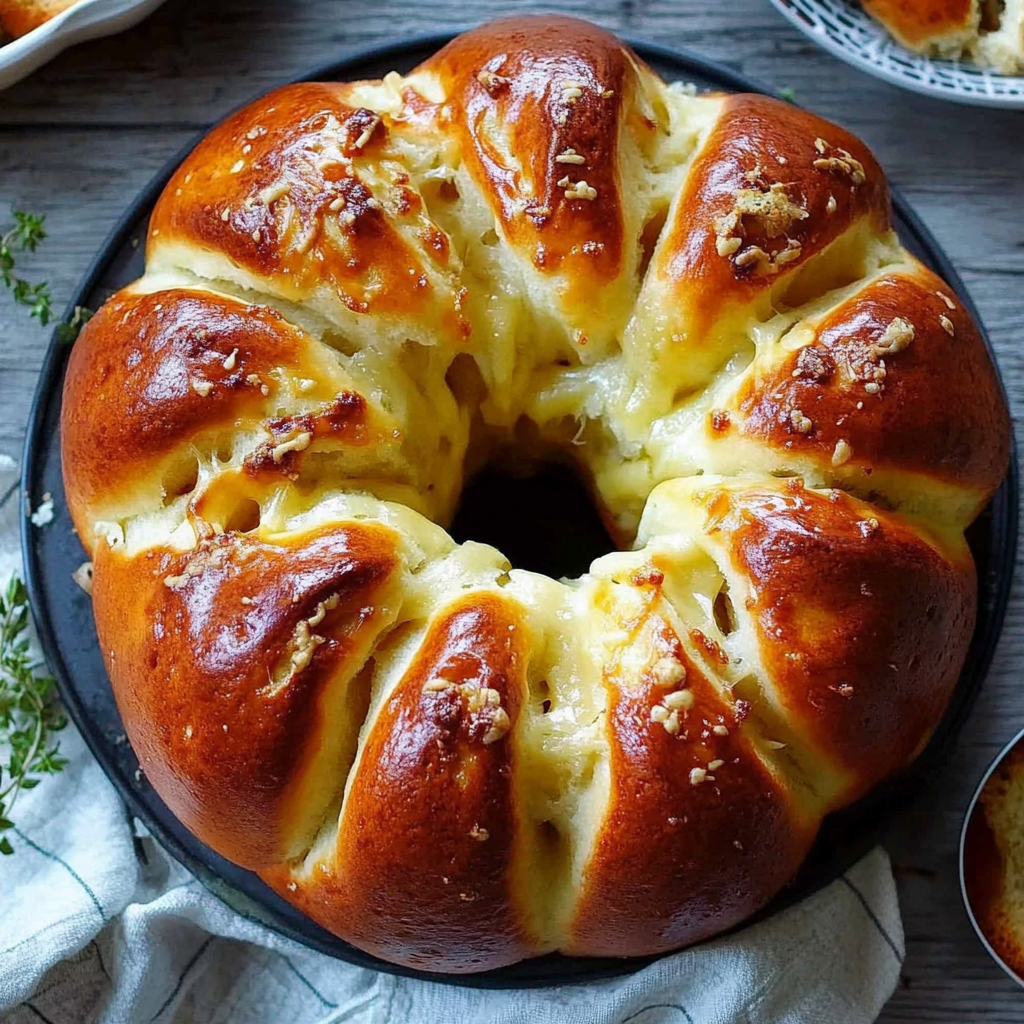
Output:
top-left (862, 0), bottom-right (1024, 75)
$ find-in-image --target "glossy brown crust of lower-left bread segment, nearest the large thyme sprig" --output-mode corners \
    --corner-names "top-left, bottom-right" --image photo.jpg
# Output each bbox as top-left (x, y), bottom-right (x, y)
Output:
top-left (92, 524), bottom-right (398, 867)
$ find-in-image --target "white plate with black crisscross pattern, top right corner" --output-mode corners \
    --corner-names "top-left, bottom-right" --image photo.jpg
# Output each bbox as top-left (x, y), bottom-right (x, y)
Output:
top-left (770, 0), bottom-right (1024, 110)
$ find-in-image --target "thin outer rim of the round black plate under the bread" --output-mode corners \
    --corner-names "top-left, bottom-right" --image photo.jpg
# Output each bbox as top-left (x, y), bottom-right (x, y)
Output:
top-left (19, 26), bottom-right (1020, 989)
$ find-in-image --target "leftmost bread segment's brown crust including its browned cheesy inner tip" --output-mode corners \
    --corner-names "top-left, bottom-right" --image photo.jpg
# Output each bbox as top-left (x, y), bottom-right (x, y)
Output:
top-left (61, 288), bottom-right (400, 545)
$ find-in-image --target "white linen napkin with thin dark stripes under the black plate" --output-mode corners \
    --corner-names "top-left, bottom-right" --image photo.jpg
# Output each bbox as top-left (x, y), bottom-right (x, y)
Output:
top-left (0, 457), bottom-right (903, 1024)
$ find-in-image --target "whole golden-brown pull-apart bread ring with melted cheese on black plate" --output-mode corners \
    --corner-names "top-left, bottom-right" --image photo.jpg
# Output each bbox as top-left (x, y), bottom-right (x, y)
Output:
top-left (62, 17), bottom-right (1010, 972)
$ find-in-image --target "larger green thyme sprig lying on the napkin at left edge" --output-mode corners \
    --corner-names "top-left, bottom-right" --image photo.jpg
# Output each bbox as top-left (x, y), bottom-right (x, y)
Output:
top-left (0, 577), bottom-right (68, 854)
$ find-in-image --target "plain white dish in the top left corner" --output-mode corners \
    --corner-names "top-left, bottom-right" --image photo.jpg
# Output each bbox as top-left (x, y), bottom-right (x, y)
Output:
top-left (0, 0), bottom-right (164, 89)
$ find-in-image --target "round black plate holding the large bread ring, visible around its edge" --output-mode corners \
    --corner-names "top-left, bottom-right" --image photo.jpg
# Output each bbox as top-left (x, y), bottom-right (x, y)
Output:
top-left (23, 35), bottom-right (1018, 988)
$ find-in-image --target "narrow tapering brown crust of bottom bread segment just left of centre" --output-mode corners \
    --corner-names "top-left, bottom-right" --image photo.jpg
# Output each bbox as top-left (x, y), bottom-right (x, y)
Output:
top-left (263, 594), bottom-right (537, 973)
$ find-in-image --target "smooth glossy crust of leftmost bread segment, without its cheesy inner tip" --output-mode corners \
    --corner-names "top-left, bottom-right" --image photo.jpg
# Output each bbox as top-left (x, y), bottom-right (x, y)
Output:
top-left (60, 289), bottom-right (304, 536)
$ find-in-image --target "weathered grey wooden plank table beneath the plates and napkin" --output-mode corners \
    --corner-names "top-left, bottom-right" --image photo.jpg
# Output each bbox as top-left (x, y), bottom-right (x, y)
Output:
top-left (0, 0), bottom-right (1024, 1024)
